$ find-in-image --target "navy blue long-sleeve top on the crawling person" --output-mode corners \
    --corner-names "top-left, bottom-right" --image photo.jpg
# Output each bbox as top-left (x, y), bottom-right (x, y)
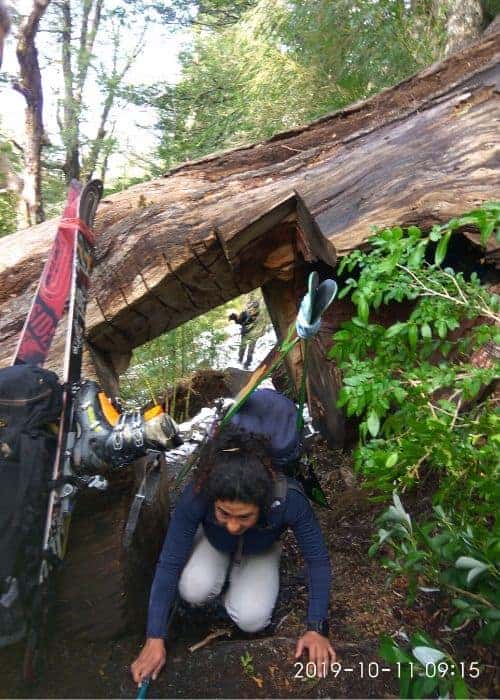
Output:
top-left (147, 479), bottom-right (331, 638)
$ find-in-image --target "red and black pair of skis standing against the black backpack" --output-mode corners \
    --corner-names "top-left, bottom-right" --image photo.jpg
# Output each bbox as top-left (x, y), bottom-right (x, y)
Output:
top-left (13, 180), bottom-right (103, 680)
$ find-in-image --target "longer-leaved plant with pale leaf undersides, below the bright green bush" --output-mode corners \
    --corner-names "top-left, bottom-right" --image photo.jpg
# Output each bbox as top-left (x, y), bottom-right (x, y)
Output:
top-left (369, 493), bottom-right (500, 644)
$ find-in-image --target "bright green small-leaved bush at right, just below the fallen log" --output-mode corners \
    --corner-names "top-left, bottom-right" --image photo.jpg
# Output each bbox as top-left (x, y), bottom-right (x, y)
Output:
top-left (330, 204), bottom-right (500, 508)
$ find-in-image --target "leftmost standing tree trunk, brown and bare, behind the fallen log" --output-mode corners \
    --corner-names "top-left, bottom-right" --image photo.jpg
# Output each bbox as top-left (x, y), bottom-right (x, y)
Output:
top-left (14, 0), bottom-right (50, 226)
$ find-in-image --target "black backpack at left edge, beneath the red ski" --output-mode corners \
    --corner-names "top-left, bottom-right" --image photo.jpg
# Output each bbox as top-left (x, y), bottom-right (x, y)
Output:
top-left (0, 365), bottom-right (62, 600)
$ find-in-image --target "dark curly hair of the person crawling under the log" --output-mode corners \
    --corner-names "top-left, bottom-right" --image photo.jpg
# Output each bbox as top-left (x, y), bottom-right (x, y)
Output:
top-left (194, 427), bottom-right (274, 512)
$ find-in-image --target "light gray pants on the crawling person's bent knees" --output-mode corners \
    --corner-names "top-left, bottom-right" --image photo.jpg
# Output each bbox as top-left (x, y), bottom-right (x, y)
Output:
top-left (179, 526), bottom-right (281, 632)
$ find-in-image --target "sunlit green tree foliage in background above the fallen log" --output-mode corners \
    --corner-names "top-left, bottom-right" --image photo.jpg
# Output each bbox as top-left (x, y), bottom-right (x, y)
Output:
top-left (156, 0), bottom-right (442, 167)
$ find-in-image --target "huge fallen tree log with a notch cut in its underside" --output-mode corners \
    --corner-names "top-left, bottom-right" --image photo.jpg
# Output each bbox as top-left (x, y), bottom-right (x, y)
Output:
top-left (0, 33), bottom-right (500, 388)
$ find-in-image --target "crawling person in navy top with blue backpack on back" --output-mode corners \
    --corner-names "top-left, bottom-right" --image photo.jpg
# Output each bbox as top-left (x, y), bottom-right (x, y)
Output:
top-left (131, 389), bottom-right (335, 683)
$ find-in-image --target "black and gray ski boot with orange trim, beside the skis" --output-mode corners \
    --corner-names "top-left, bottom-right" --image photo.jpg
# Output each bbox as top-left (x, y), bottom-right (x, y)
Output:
top-left (73, 381), bottom-right (182, 473)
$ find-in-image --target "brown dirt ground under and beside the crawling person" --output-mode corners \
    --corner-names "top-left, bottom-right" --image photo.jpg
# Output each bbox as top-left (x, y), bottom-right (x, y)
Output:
top-left (0, 445), bottom-right (496, 698)
